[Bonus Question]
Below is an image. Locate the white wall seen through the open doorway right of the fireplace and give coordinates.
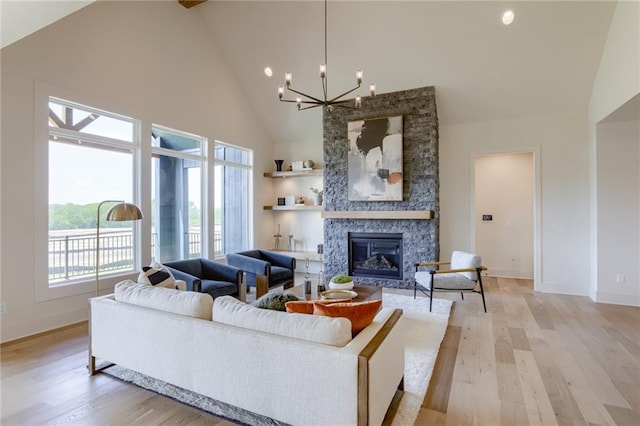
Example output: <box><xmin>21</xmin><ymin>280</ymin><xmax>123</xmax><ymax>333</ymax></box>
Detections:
<box><xmin>474</xmin><ymin>153</ymin><xmax>534</xmax><ymax>279</ymax></box>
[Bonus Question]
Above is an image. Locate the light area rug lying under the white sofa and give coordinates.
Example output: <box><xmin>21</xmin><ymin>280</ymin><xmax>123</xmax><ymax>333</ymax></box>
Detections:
<box><xmin>103</xmin><ymin>292</ymin><xmax>451</xmax><ymax>426</ymax></box>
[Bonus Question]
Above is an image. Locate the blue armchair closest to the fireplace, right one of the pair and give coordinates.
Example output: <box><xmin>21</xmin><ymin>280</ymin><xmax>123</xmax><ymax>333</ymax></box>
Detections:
<box><xmin>227</xmin><ymin>250</ymin><xmax>296</xmax><ymax>298</ymax></box>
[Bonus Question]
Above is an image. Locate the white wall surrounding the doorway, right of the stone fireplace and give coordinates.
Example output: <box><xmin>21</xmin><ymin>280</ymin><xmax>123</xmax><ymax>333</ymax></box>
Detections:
<box><xmin>440</xmin><ymin>113</ymin><xmax>590</xmax><ymax>295</ymax></box>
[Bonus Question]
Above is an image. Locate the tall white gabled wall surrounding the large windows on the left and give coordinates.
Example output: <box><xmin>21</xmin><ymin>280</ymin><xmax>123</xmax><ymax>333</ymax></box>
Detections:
<box><xmin>0</xmin><ymin>2</ymin><xmax>272</xmax><ymax>341</ymax></box>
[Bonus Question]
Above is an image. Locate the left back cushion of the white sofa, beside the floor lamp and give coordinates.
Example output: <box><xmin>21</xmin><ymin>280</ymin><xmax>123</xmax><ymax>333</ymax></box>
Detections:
<box><xmin>115</xmin><ymin>280</ymin><xmax>213</xmax><ymax>321</ymax></box>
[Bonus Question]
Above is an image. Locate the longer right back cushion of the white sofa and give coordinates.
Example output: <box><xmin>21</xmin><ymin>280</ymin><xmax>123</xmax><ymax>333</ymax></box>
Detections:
<box><xmin>213</xmin><ymin>296</ymin><xmax>351</xmax><ymax>346</ymax></box>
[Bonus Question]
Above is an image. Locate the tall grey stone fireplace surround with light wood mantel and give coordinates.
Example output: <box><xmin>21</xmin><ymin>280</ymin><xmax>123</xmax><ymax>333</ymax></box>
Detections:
<box><xmin>323</xmin><ymin>87</ymin><xmax>440</xmax><ymax>288</ymax></box>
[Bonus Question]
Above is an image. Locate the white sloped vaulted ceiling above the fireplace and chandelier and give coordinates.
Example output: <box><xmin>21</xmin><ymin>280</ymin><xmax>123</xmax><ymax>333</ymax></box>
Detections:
<box><xmin>1</xmin><ymin>0</ymin><xmax>615</xmax><ymax>142</ymax></box>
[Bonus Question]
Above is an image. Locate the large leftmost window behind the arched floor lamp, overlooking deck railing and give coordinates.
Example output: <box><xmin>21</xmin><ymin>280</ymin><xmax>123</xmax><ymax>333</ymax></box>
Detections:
<box><xmin>48</xmin><ymin>97</ymin><xmax>139</xmax><ymax>287</ymax></box>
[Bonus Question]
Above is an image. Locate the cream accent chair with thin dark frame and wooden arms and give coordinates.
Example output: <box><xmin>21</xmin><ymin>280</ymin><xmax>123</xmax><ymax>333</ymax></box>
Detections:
<box><xmin>413</xmin><ymin>251</ymin><xmax>487</xmax><ymax>312</ymax></box>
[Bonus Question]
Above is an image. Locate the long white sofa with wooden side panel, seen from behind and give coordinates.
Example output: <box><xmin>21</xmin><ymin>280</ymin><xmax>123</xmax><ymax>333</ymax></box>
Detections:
<box><xmin>89</xmin><ymin>282</ymin><xmax>404</xmax><ymax>425</ymax></box>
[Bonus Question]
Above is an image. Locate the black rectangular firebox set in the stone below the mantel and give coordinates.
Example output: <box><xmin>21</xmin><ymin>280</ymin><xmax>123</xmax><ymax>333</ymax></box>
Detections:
<box><xmin>349</xmin><ymin>232</ymin><xmax>402</xmax><ymax>280</ymax></box>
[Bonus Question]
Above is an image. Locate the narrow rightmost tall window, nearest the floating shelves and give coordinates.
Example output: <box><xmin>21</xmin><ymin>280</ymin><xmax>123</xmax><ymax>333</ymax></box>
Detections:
<box><xmin>214</xmin><ymin>141</ymin><xmax>253</xmax><ymax>257</ymax></box>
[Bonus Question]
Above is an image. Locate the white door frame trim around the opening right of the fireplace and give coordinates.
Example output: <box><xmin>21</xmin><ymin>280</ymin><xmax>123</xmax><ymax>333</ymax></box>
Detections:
<box><xmin>469</xmin><ymin>146</ymin><xmax>542</xmax><ymax>291</ymax></box>
